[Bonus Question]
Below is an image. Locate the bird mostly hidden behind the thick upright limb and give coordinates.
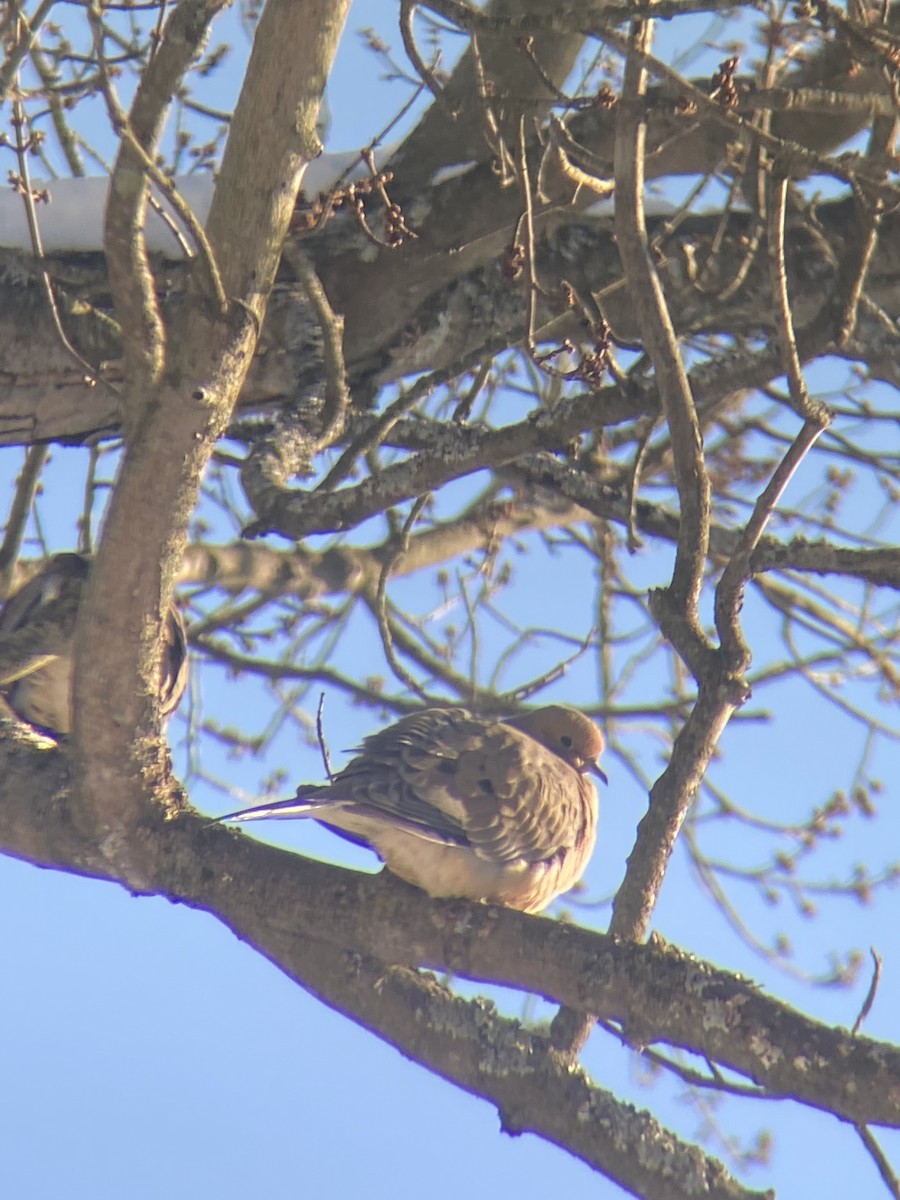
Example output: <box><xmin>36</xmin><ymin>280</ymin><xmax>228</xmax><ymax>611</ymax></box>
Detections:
<box><xmin>0</xmin><ymin>553</ymin><xmax>188</xmax><ymax>733</ymax></box>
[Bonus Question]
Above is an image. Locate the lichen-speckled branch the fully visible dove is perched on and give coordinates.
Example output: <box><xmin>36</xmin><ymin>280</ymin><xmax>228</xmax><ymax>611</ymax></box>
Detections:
<box><xmin>0</xmin><ymin>744</ymin><xmax>900</xmax><ymax>1127</ymax></box>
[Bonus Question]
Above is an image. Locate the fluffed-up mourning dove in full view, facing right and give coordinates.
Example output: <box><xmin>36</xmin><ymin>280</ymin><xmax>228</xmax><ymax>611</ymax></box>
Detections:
<box><xmin>220</xmin><ymin>704</ymin><xmax>606</xmax><ymax>912</ymax></box>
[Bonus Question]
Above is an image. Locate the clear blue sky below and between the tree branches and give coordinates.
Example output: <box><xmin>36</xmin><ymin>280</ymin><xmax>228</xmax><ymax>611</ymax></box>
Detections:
<box><xmin>0</xmin><ymin>0</ymin><xmax>900</xmax><ymax>1200</ymax></box>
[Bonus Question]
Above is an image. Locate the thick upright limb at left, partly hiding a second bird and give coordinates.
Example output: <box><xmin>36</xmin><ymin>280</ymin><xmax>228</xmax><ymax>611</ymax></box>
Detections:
<box><xmin>73</xmin><ymin>0</ymin><xmax>349</xmax><ymax>887</ymax></box>
